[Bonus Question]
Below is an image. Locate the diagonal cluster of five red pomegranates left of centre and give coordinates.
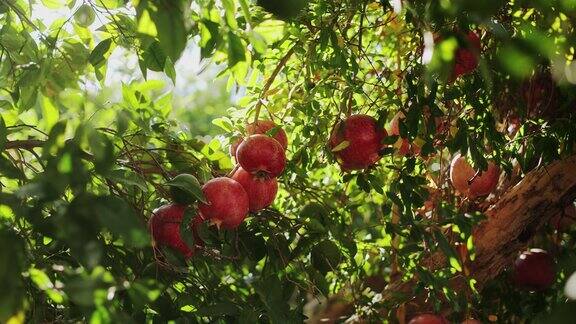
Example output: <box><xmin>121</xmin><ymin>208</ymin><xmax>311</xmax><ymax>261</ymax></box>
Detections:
<box><xmin>150</xmin><ymin>121</ymin><xmax>288</xmax><ymax>258</ymax></box>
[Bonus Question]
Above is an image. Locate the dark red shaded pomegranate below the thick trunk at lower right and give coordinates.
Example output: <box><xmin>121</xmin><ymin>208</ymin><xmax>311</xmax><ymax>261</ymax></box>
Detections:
<box><xmin>512</xmin><ymin>249</ymin><xmax>556</xmax><ymax>291</ymax></box>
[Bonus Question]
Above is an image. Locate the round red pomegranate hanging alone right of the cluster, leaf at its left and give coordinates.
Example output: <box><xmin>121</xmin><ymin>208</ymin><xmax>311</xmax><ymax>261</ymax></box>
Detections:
<box><xmin>329</xmin><ymin>115</ymin><xmax>388</xmax><ymax>171</ymax></box>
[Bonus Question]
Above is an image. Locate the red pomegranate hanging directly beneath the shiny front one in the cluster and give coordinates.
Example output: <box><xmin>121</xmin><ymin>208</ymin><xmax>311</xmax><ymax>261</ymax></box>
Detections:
<box><xmin>232</xmin><ymin>168</ymin><xmax>278</xmax><ymax>212</ymax></box>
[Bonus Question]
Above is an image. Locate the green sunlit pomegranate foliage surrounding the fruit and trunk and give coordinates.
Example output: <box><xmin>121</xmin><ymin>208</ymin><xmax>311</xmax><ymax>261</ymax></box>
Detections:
<box><xmin>0</xmin><ymin>0</ymin><xmax>576</xmax><ymax>323</ymax></box>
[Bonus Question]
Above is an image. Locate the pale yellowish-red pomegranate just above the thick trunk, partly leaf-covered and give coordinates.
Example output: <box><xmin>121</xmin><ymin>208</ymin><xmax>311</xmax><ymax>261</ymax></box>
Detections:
<box><xmin>450</xmin><ymin>154</ymin><xmax>500</xmax><ymax>198</ymax></box>
